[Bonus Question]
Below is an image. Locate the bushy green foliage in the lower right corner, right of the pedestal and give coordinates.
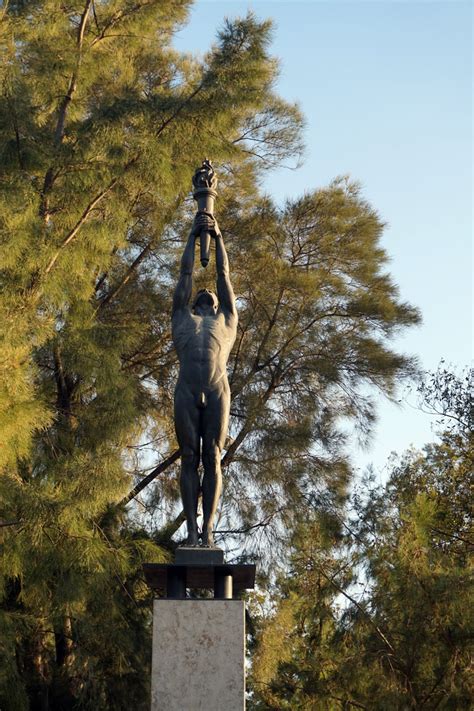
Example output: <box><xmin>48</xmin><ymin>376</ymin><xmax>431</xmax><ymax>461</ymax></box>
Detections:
<box><xmin>253</xmin><ymin>371</ymin><xmax>473</xmax><ymax>711</ymax></box>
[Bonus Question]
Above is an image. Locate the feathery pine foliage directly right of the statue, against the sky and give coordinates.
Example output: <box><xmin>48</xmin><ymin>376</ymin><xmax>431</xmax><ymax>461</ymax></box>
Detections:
<box><xmin>207</xmin><ymin>179</ymin><xmax>418</xmax><ymax>551</ymax></box>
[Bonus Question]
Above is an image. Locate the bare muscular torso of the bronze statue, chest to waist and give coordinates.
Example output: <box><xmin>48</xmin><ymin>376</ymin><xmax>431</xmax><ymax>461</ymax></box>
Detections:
<box><xmin>173</xmin><ymin>308</ymin><xmax>236</xmax><ymax>391</ymax></box>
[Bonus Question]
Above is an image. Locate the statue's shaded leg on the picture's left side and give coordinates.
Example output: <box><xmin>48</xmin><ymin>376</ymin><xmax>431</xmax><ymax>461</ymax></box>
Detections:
<box><xmin>174</xmin><ymin>385</ymin><xmax>199</xmax><ymax>546</ymax></box>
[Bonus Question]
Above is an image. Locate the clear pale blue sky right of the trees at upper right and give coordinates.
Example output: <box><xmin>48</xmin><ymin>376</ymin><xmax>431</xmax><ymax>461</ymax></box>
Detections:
<box><xmin>175</xmin><ymin>0</ymin><xmax>472</xmax><ymax>478</ymax></box>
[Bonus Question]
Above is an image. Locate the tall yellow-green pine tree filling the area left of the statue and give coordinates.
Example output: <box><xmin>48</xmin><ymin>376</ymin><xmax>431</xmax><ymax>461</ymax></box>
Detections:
<box><xmin>0</xmin><ymin>0</ymin><xmax>301</xmax><ymax>711</ymax></box>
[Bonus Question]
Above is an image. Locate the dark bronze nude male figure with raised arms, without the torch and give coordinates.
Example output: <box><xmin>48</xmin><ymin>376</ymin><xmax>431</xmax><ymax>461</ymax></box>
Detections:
<box><xmin>172</xmin><ymin>213</ymin><xmax>237</xmax><ymax>546</ymax></box>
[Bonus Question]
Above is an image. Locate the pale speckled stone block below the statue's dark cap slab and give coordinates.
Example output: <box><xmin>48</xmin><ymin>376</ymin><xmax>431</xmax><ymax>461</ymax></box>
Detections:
<box><xmin>151</xmin><ymin>599</ymin><xmax>245</xmax><ymax>711</ymax></box>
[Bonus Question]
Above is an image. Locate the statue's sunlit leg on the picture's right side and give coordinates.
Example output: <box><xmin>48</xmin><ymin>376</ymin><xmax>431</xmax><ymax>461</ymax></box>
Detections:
<box><xmin>201</xmin><ymin>388</ymin><xmax>230</xmax><ymax>546</ymax></box>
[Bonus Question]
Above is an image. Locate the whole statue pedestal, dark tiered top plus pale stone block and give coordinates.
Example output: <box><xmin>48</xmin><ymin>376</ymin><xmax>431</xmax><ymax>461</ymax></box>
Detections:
<box><xmin>143</xmin><ymin>546</ymin><xmax>255</xmax><ymax>711</ymax></box>
